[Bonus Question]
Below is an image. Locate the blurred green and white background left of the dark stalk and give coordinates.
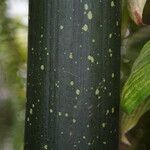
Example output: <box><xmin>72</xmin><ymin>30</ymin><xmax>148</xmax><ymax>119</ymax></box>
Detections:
<box><xmin>0</xmin><ymin>0</ymin><xmax>27</xmax><ymax>150</ymax></box>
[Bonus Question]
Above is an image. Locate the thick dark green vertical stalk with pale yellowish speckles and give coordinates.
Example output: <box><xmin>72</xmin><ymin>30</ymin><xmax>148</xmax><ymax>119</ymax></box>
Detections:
<box><xmin>25</xmin><ymin>0</ymin><xmax>120</xmax><ymax>150</ymax></box>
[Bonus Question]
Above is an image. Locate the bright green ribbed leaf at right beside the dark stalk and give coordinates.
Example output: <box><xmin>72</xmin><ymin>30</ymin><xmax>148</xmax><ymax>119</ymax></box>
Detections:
<box><xmin>121</xmin><ymin>41</ymin><xmax>150</xmax><ymax>113</ymax></box>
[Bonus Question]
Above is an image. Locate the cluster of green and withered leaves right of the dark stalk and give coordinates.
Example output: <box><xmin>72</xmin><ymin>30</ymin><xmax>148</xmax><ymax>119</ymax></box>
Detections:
<box><xmin>120</xmin><ymin>0</ymin><xmax>150</xmax><ymax>150</ymax></box>
